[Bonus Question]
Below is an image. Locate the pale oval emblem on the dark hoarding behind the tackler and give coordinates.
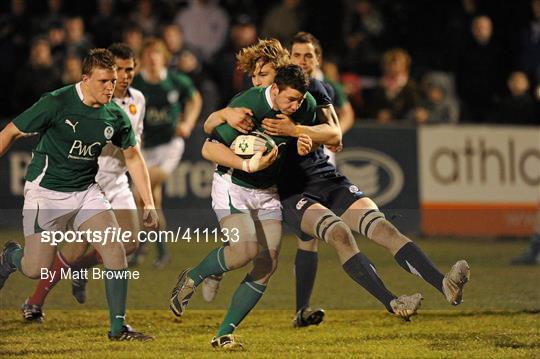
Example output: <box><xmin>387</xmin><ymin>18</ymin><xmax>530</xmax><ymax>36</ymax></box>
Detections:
<box><xmin>337</xmin><ymin>147</ymin><xmax>404</xmax><ymax>206</ymax></box>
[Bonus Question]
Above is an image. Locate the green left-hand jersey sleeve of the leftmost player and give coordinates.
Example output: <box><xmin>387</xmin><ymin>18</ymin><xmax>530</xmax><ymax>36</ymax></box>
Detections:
<box><xmin>13</xmin><ymin>94</ymin><xmax>59</xmax><ymax>133</ymax></box>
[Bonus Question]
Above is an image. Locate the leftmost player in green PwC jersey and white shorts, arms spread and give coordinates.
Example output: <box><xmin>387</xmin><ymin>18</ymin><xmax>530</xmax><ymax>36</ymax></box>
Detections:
<box><xmin>0</xmin><ymin>49</ymin><xmax>158</xmax><ymax>341</ymax></box>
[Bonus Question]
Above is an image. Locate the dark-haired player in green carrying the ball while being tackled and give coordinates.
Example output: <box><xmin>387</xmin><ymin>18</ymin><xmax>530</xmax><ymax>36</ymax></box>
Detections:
<box><xmin>170</xmin><ymin>65</ymin><xmax>316</xmax><ymax>349</ymax></box>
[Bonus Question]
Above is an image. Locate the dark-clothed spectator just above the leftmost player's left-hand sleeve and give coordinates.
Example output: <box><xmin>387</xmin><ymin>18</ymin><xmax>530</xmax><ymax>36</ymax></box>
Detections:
<box><xmin>13</xmin><ymin>37</ymin><xmax>62</xmax><ymax>113</ymax></box>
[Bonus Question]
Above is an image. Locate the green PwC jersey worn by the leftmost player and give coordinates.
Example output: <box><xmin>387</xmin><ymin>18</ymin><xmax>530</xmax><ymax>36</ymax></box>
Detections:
<box><xmin>13</xmin><ymin>85</ymin><xmax>137</xmax><ymax>192</ymax></box>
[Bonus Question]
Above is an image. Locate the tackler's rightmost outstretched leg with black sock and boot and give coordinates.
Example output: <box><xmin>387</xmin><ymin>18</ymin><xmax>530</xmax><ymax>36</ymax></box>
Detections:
<box><xmin>341</xmin><ymin>197</ymin><xmax>469</xmax><ymax>305</ymax></box>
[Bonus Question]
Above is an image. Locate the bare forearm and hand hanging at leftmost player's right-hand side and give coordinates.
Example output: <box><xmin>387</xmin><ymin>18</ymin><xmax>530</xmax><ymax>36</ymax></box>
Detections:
<box><xmin>122</xmin><ymin>146</ymin><xmax>159</xmax><ymax>228</ymax></box>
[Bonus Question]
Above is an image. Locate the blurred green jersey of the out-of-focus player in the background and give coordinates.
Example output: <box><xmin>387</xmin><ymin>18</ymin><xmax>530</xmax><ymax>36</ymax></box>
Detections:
<box><xmin>133</xmin><ymin>70</ymin><xmax>195</xmax><ymax>148</ymax></box>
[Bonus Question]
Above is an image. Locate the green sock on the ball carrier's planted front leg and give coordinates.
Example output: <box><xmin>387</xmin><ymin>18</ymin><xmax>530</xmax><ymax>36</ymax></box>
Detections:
<box><xmin>216</xmin><ymin>274</ymin><xmax>266</xmax><ymax>337</ymax></box>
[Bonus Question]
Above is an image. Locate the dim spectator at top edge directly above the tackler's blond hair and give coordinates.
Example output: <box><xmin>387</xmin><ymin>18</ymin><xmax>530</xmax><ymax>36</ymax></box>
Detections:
<box><xmin>261</xmin><ymin>0</ymin><xmax>303</xmax><ymax>46</ymax></box>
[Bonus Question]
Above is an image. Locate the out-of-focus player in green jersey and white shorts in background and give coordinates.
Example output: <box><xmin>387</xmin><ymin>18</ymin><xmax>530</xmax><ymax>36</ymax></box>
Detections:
<box><xmin>133</xmin><ymin>38</ymin><xmax>202</xmax><ymax>268</ymax></box>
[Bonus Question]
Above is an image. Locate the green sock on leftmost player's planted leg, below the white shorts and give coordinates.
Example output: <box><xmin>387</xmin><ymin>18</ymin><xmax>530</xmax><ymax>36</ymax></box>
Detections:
<box><xmin>104</xmin><ymin>269</ymin><xmax>128</xmax><ymax>335</ymax></box>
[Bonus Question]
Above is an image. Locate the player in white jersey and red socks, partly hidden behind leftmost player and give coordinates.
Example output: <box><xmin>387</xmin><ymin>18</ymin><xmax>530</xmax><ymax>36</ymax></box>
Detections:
<box><xmin>21</xmin><ymin>43</ymin><xmax>145</xmax><ymax>321</ymax></box>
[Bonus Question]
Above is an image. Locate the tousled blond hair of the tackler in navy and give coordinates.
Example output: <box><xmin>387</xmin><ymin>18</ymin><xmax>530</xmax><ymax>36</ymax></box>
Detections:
<box><xmin>236</xmin><ymin>39</ymin><xmax>290</xmax><ymax>74</ymax></box>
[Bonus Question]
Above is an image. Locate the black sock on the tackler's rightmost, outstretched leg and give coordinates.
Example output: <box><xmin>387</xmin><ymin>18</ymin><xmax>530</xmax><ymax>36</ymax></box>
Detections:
<box><xmin>394</xmin><ymin>242</ymin><xmax>444</xmax><ymax>293</ymax></box>
